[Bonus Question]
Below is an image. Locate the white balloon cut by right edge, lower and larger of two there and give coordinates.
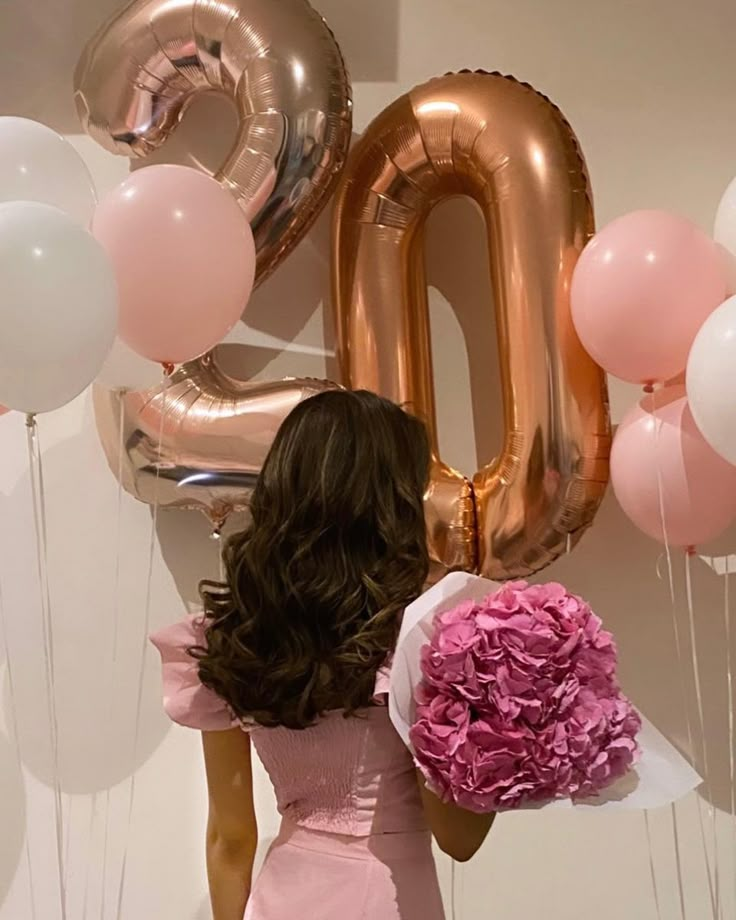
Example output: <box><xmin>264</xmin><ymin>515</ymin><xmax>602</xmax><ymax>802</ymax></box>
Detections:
<box><xmin>687</xmin><ymin>297</ymin><xmax>736</xmax><ymax>464</ymax></box>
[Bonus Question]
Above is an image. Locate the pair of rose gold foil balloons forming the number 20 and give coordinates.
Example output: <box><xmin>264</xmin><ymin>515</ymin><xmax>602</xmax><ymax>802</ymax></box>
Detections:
<box><xmin>77</xmin><ymin>18</ymin><xmax>610</xmax><ymax>578</ymax></box>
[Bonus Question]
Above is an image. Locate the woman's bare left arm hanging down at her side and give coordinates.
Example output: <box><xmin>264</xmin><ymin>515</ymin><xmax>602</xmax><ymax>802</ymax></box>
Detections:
<box><xmin>202</xmin><ymin>728</ymin><xmax>258</xmax><ymax>920</ymax></box>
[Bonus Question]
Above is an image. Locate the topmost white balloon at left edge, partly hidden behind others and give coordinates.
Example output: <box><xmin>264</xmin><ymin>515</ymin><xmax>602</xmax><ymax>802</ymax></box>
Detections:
<box><xmin>0</xmin><ymin>115</ymin><xmax>97</xmax><ymax>227</ymax></box>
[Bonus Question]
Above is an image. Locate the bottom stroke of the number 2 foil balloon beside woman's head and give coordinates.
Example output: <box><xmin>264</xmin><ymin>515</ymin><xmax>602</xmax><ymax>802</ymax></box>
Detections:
<box><xmin>94</xmin><ymin>355</ymin><xmax>335</xmax><ymax>530</ymax></box>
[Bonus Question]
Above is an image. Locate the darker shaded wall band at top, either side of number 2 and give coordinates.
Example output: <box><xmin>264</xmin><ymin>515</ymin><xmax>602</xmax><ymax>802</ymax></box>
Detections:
<box><xmin>0</xmin><ymin>0</ymin><xmax>399</xmax><ymax>134</ymax></box>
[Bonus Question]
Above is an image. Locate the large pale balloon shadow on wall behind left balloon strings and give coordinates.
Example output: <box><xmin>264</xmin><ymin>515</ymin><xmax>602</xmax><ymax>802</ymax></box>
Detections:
<box><xmin>2</xmin><ymin>422</ymin><xmax>173</xmax><ymax>796</ymax></box>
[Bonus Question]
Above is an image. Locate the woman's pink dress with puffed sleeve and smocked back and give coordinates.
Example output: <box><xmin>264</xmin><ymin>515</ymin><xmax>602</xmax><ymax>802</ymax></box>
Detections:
<box><xmin>152</xmin><ymin>618</ymin><xmax>445</xmax><ymax>920</ymax></box>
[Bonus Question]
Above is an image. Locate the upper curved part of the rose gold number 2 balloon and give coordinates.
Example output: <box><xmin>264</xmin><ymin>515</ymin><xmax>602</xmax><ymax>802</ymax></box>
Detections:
<box><xmin>74</xmin><ymin>0</ymin><xmax>352</xmax><ymax>281</ymax></box>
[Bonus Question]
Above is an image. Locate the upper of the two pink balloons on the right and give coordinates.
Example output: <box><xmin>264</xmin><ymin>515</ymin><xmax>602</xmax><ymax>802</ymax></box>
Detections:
<box><xmin>571</xmin><ymin>211</ymin><xmax>726</xmax><ymax>384</ymax></box>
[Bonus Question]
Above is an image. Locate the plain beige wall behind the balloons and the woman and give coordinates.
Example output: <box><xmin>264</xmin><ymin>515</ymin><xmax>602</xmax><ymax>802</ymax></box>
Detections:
<box><xmin>0</xmin><ymin>0</ymin><xmax>736</xmax><ymax>920</ymax></box>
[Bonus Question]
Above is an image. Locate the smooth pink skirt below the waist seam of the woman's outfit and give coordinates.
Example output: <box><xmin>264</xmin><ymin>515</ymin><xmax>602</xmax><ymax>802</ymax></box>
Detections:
<box><xmin>244</xmin><ymin>822</ymin><xmax>445</xmax><ymax>920</ymax></box>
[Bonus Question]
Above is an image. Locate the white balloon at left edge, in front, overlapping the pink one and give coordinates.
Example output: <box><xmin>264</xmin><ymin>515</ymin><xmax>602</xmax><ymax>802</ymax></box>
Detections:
<box><xmin>0</xmin><ymin>201</ymin><xmax>117</xmax><ymax>413</ymax></box>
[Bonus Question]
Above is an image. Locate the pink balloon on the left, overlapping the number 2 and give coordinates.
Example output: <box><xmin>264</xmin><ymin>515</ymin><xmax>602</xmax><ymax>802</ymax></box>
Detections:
<box><xmin>92</xmin><ymin>165</ymin><xmax>256</xmax><ymax>364</ymax></box>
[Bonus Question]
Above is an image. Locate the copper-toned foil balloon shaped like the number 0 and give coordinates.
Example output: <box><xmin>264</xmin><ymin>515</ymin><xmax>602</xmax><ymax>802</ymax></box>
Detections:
<box><xmin>334</xmin><ymin>72</ymin><xmax>610</xmax><ymax>579</ymax></box>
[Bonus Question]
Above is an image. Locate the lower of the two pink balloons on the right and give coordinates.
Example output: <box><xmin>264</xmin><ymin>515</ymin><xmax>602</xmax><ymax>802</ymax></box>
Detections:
<box><xmin>611</xmin><ymin>386</ymin><xmax>736</xmax><ymax>547</ymax></box>
